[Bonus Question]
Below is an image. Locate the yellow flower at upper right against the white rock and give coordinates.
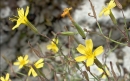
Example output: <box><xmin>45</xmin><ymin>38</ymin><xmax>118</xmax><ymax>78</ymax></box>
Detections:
<box><xmin>99</xmin><ymin>0</ymin><xmax>116</xmax><ymax>17</ymax></box>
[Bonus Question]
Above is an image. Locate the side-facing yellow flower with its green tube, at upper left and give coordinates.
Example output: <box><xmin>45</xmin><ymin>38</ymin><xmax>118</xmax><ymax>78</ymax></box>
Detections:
<box><xmin>9</xmin><ymin>6</ymin><xmax>38</xmax><ymax>32</ymax></box>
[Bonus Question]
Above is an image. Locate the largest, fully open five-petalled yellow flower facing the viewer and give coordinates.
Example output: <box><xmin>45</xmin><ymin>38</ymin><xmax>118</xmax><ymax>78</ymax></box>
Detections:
<box><xmin>75</xmin><ymin>39</ymin><xmax>103</xmax><ymax>66</ymax></box>
